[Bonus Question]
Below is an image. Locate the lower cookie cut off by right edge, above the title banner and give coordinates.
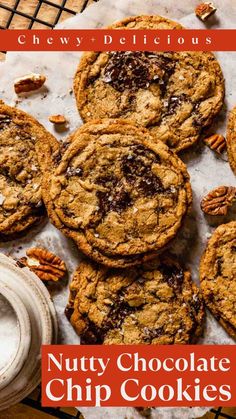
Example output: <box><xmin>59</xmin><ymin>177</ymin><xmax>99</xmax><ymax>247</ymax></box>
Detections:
<box><xmin>200</xmin><ymin>221</ymin><xmax>236</xmax><ymax>339</ymax></box>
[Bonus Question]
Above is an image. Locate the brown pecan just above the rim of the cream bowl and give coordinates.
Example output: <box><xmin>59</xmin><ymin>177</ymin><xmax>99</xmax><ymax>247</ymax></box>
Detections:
<box><xmin>18</xmin><ymin>247</ymin><xmax>67</xmax><ymax>281</ymax></box>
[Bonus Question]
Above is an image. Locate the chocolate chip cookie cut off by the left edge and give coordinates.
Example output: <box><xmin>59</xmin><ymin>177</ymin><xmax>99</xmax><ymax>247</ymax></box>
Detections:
<box><xmin>0</xmin><ymin>101</ymin><xmax>57</xmax><ymax>241</ymax></box>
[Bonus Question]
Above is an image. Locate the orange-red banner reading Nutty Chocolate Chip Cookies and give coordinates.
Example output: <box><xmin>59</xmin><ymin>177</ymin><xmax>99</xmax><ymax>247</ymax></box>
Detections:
<box><xmin>42</xmin><ymin>345</ymin><xmax>236</xmax><ymax>406</ymax></box>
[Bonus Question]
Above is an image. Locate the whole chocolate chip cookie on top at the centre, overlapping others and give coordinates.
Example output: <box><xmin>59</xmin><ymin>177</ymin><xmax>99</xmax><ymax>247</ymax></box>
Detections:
<box><xmin>40</xmin><ymin>119</ymin><xmax>191</xmax><ymax>267</ymax></box>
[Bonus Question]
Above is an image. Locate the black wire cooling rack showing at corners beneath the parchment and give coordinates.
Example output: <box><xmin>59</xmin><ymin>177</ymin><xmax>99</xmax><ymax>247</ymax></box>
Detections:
<box><xmin>0</xmin><ymin>0</ymin><xmax>236</xmax><ymax>419</ymax></box>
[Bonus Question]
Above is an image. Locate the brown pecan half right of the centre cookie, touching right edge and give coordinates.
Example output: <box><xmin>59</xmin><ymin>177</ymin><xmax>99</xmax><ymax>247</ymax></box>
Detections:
<box><xmin>201</xmin><ymin>186</ymin><xmax>236</xmax><ymax>215</ymax></box>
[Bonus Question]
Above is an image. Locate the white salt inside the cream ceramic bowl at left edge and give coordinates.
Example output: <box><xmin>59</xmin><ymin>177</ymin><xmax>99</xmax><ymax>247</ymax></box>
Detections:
<box><xmin>0</xmin><ymin>295</ymin><xmax>20</xmax><ymax>372</ymax></box>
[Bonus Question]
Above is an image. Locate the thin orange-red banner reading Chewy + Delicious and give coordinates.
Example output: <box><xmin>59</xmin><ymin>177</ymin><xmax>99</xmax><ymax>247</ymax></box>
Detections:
<box><xmin>0</xmin><ymin>29</ymin><xmax>236</xmax><ymax>51</ymax></box>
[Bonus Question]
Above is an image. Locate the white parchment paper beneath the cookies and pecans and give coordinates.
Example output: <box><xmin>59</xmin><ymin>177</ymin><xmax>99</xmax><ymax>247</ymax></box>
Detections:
<box><xmin>0</xmin><ymin>0</ymin><xmax>236</xmax><ymax>419</ymax></box>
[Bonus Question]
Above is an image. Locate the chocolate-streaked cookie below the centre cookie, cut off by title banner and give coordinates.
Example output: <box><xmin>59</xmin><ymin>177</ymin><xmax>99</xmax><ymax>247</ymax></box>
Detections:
<box><xmin>66</xmin><ymin>256</ymin><xmax>204</xmax><ymax>344</ymax></box>
